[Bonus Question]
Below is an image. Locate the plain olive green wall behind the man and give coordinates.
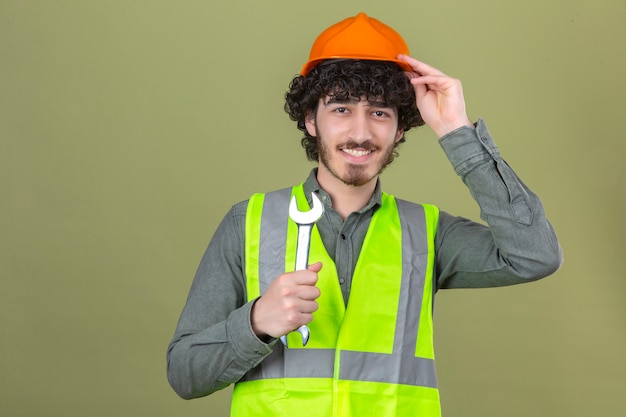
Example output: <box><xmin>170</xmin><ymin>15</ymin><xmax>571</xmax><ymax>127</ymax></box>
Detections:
<box><xmin>0</xmin><ymin>0</ymin><xmax>626</xmax><ymax>417</ymax></box>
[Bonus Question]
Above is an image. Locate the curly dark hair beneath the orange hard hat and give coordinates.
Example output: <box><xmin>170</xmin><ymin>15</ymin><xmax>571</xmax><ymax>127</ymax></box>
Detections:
<box><xmin>285</xmin><ymin>59</ymin><xmax>424</xmax><ymax>161</ymax></box>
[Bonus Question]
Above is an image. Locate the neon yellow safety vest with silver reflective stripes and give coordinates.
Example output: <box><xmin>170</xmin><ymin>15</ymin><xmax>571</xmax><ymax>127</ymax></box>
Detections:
<box><xmin>231</xmin><ymin>184</ymin><xmax>441</xmax><ymax>417</ymax></box>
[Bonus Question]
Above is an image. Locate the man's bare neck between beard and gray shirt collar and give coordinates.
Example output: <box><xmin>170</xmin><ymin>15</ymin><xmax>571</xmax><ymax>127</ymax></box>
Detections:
<box><xmin>317</xmin><ymin>169</ymin><xmax>378</xmax><ymax>220</ymax></box>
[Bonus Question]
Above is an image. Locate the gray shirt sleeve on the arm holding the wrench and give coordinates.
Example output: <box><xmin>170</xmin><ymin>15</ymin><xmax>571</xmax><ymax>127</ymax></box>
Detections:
<box><xmin>167</xmin><ymin>203</ymin><xmax>275</xmax><ymax>399</ymax></box>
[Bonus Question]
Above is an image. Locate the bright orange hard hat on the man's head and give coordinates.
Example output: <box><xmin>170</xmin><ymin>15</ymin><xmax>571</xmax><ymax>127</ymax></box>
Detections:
<box><xmin>300</xmin><ymin>13</ymin><xmax>413</xmax><ymax>75</ymax></box>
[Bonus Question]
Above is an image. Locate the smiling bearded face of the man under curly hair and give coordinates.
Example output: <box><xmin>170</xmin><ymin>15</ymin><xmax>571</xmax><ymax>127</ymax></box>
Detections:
<box><xmin>305</xmin><ymin>96</ymin><xmax>404</xmax><ymax>187</ymax></box>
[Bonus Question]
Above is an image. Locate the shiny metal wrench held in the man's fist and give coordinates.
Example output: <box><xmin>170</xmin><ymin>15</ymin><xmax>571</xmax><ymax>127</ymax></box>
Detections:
<box><xmin>280</xmin><ymin>193</ymin><xmax>324</xmax><ymax>347</ymax></box>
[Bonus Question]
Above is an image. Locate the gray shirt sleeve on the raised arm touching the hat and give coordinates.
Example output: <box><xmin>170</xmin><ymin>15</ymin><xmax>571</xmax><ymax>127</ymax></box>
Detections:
<box><xmin>435</xmin><ymin>119</ymin><xmax>563</xmax><ymax>288</ymax></box>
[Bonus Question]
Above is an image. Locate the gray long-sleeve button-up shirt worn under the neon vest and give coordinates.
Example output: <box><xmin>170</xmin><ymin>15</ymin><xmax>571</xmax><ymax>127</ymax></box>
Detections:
<box><xmin>167</xmin><ymin>120</ymin><xmax>562</xmax><ymax>398</ymax></box>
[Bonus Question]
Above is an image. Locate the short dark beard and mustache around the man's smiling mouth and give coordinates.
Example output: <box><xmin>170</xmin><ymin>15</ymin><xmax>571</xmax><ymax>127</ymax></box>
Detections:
<box><xmin>317</xmin><ymin>136</ymin><xmax>395</xmax><ymax>187</ymax></box>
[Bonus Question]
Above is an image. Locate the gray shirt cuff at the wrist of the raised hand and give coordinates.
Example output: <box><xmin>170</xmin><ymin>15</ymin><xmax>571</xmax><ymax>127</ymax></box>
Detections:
<box><xmin>439</xmin><ymin>119</ymin><xmax>500</xmax><ymax>176</ymax></box>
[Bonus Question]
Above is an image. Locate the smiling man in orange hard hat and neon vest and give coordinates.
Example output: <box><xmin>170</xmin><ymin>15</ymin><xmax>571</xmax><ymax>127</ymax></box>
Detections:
<box><xmin>168</xmin><ymin>13</ymin><xmax>562</xmax><ymax>416</ymax></box>
